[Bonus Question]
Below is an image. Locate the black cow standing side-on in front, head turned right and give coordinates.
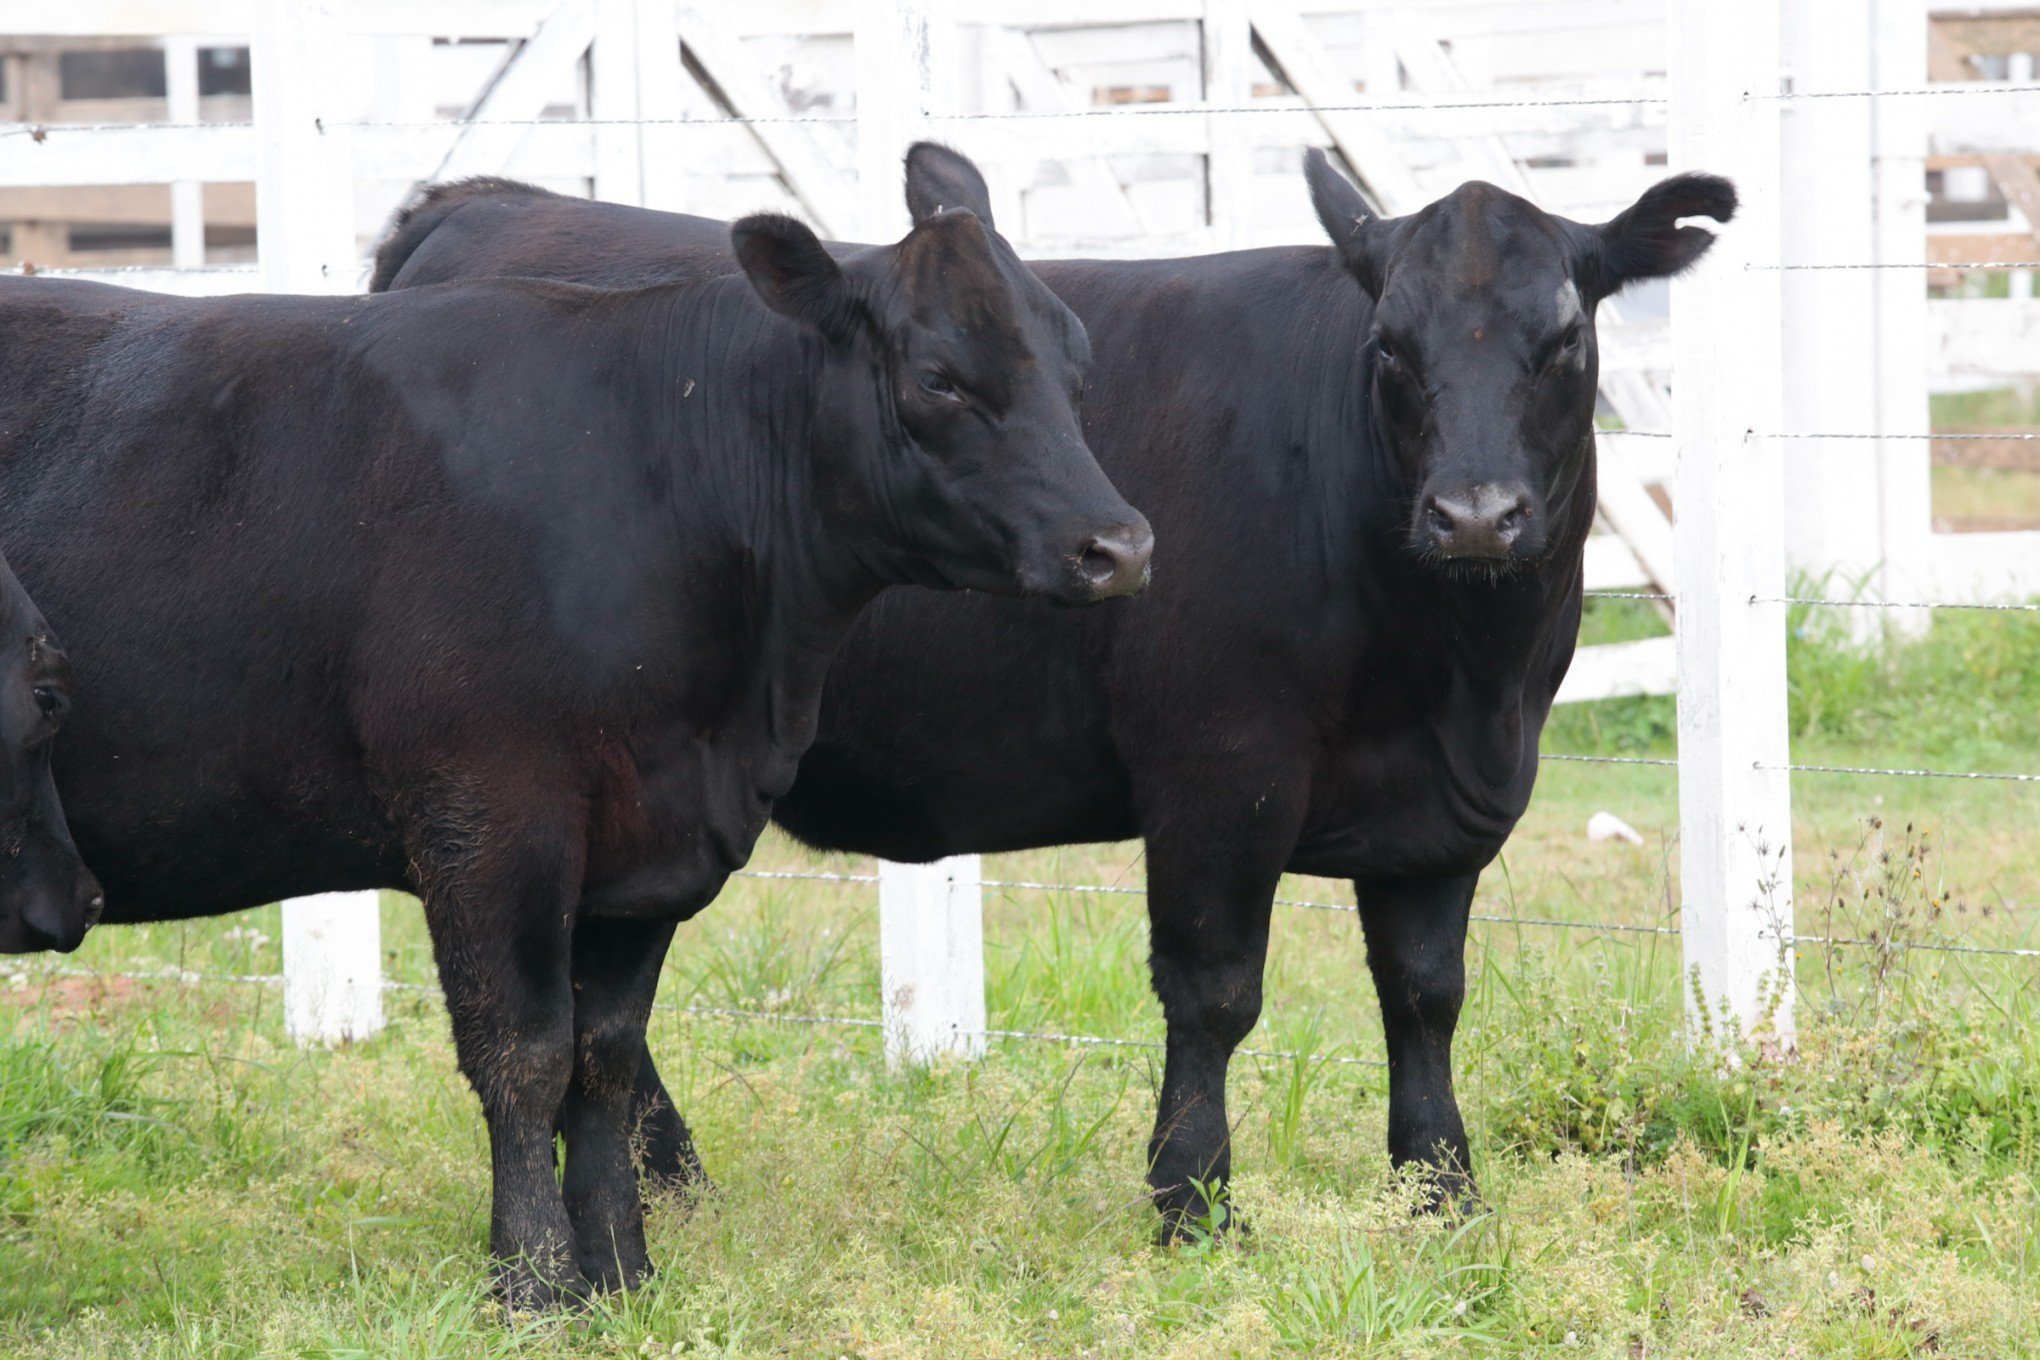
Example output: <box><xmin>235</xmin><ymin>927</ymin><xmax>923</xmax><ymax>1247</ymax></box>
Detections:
<box><xmin>0</xmin><ymin>151</ymin><xmax>1151</xmax><ymax>1305</ymax></box>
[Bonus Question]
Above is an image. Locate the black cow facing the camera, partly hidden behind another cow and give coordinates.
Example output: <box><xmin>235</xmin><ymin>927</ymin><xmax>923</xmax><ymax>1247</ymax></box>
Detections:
<box><xmin>373</xmin><ymin>153</ymin><xmax>1736</xmax><ymax>1234</ymax></box>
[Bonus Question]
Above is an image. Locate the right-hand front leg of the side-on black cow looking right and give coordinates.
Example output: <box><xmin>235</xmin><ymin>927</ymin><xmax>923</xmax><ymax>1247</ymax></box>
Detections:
<box><xmin>561</xmin><ymin>920</ymin><xmax>673</xmax><ymax>1289</ymax></box>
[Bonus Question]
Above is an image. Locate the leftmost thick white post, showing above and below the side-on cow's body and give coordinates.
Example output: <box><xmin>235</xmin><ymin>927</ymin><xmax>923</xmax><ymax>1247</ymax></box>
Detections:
<box><xmin>251</xmin><ymin>0</ymin><xmax>384</xmax><ymax>1044</ymax></box>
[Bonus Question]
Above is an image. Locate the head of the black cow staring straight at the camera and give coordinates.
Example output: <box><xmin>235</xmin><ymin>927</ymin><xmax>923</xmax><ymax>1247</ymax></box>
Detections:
<box><xmin>1304</xmin><ymin>149</ymin><xmax>1736</xmax><ymax>571</ymax></box>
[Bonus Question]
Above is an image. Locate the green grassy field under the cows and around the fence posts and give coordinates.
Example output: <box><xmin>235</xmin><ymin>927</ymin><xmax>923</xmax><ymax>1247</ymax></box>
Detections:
<box><xmin>0</xmin><ymin>610</ymin><xmax>2040</xmax><ymax>1360</ymax></box>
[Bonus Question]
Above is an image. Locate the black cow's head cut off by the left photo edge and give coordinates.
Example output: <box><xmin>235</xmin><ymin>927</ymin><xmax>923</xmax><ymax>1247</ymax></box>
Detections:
<box><xmin>0</xmin><ymin>561</ymin><xmax>106</xmax><ymax>954</ymax></box>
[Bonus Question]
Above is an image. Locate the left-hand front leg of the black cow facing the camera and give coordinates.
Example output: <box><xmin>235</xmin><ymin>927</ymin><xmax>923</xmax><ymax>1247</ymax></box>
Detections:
<box><xmin>1146</xmin><ymin>782</ymin><xmax>1295</xmax><ymax>1242</ymax></box>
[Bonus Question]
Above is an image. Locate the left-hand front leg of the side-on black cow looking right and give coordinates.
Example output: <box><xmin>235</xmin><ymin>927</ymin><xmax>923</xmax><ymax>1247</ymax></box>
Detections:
<box><xmin>416</xmin><ymin>812</ymin><xmax>588</xmax><ymax>1309</ymax></box>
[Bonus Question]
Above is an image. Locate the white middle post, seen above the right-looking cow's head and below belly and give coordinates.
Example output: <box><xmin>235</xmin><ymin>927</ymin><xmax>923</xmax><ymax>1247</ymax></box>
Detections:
<box><xmin>857</xmin><ymin>0</ymin><xmax>985</xmax><ymax>1064</ymax></box>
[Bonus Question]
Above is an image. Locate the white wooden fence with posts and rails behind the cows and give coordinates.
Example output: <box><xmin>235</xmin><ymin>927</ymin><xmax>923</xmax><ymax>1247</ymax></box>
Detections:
<box><xmin>0</xmin><ymin>0</ymin><xmax>2040</xmax><ymax>1058</ymax></box>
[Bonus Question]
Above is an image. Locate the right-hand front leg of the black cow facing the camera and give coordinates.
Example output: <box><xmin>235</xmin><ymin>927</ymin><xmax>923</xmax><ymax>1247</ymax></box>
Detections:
<box><xmin>1353</xmin><ymin>875</ymin><xmax>1479</xmax><ymax>1203</ymax></box>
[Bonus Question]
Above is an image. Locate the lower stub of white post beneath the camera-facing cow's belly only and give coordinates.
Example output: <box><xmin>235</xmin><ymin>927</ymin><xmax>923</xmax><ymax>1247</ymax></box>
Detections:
<box><xmin>879</xmin><ymin>854</ymin><xmax>985</xmax><ymax>1064</ymax></box>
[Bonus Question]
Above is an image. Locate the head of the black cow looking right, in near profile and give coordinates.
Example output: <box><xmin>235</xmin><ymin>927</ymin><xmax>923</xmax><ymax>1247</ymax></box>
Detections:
<box><xmin>730</xmin><ymin>143</ymin><xmax>1155</xmax><ymax>604</ymax></box>
